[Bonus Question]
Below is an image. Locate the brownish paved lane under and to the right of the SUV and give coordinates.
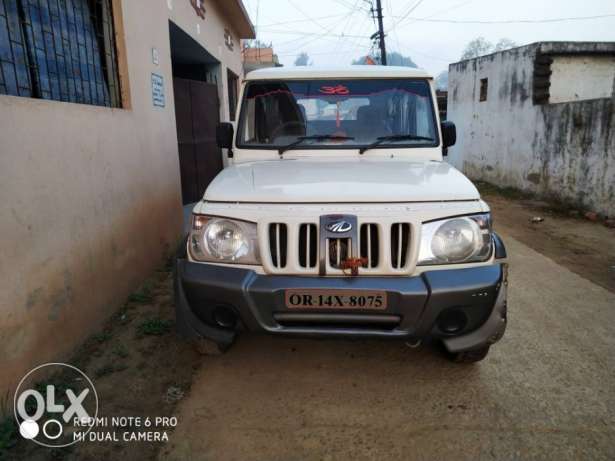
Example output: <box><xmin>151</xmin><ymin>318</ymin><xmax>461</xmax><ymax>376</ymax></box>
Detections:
<box><xmin>159</xmin><ymin>234</ymin><xmax>615</xmax><ymax>460</ymax></box>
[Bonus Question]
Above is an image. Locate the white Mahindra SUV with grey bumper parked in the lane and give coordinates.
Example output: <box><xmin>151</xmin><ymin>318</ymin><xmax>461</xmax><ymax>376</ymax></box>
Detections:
<box><xmin>175</xmin><ymin>66</ymin><xmax>507</xmax><ymax>362</ymax></box>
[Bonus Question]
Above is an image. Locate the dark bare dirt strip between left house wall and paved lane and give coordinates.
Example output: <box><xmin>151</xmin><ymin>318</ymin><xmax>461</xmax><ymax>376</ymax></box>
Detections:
<box><xmin>6</xmin><ymin>265</ymin><xmax>203</xmax><ymax>461</ymax></box>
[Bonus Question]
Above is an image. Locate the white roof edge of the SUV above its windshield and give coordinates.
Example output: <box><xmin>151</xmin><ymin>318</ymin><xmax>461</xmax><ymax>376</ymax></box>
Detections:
<box><xmin>246</xmin><ymin>65</ymin><xmax>432</xmax><ymax>80</ymax></box>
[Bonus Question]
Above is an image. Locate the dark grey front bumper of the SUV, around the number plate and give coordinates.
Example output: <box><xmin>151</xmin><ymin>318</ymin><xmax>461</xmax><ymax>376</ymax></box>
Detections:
<box><xmin>175</xmin><ymin>239</ymin><xmax>506</xmax><ymax>352</ymax></box>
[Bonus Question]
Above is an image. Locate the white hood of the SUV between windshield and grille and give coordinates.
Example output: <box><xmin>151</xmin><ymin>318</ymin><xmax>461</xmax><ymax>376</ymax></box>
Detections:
<box><xmin>205</xmin><ymin>159</ymin><xmax>479</xmax><ymax>203</ymax></box>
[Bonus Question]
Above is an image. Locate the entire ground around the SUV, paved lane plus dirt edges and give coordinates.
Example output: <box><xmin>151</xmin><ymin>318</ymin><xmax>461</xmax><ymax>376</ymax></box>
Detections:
<box><xmin>7</xmin><ymin>185</ymin><xmax>615</xmax><ymax>460</ymax></box>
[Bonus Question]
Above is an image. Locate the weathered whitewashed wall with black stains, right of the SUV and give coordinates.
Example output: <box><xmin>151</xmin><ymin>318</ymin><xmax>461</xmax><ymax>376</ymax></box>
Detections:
<box><xmin>448</xmin><ymin>44</ymin><xmax>615</xmax><ymax>216</ymax></box>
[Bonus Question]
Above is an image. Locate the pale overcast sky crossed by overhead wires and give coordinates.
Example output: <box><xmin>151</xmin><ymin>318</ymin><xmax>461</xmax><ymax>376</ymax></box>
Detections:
<box><xmin>243</xmin><ymin>0</ymin><xmax>615</xmax><ymax>75</ymax></box>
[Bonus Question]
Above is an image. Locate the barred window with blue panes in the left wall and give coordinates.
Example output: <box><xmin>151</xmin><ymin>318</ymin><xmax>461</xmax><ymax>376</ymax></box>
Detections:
<box><xmin>0</xmin><ymin>0</ymin><xmax>121</xmax><ymax>107</ymax></box>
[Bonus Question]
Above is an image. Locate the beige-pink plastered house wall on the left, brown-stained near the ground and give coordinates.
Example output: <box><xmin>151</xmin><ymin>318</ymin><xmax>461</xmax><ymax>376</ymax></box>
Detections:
<box><xmin>0</xmin><ymin>0</ymin><xmax>250</xmax><ymax>397</ymax></box>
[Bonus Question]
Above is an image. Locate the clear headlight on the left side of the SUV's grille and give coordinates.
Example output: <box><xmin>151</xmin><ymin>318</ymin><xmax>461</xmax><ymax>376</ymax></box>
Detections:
<box><xmin>188</xmin><ymin>215</ymin><xmax>260</xmax><ymax>264</ymax></box>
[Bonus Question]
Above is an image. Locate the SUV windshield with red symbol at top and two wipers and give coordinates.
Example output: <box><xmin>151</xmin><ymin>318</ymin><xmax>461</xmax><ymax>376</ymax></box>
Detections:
<box><xmin>238</xmin><ymin>79</ymin><xmax>438</xmax><ymax>149</ymax></box>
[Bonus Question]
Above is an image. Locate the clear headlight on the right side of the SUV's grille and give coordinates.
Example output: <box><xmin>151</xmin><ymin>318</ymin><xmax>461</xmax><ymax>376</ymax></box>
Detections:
<box><xmin>418</xmin><ymin>213</ymin><xmax>491</xmax><ymax>265</ymax></box>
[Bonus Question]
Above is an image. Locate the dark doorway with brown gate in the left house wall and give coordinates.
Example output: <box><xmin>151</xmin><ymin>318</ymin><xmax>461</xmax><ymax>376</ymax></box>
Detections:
<box><xmin>169</xmin><ymin>22</ymin><xmax>223</xmax><ymax>204</ymax></box>
